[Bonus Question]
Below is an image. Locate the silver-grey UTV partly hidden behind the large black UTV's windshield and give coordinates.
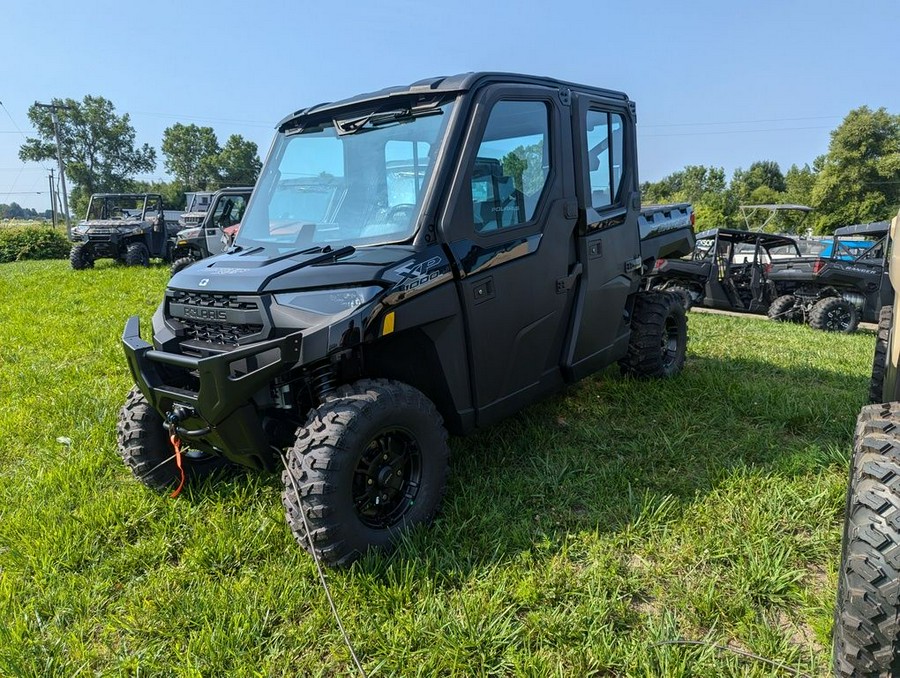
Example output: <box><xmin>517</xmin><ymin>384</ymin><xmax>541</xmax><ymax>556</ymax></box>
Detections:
<box><xmin>172</xmin><ymin>186</ymin><xmax>253</xmax><ymax>275</ymax></box>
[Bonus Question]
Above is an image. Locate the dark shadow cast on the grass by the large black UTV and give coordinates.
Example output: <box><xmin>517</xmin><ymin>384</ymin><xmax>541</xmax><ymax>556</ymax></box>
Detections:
<box><xmin>169</xmin><ymin>357</ymin><xmax>866</xmax><ymax>579</ymax></box>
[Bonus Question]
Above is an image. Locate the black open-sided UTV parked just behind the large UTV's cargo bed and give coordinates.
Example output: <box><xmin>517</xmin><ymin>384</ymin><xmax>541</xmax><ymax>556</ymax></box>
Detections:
<box><xmin>648</xmin><ymin>228</ymin><xmax>800</xmax><ymax>313</ymax></box>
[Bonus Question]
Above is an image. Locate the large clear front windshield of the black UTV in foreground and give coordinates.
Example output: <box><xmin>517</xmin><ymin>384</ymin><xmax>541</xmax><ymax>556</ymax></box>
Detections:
<box><xmin>235</xmin><ymin>97</ymin><xmax>453</xmax><ymax>254</ymax></box>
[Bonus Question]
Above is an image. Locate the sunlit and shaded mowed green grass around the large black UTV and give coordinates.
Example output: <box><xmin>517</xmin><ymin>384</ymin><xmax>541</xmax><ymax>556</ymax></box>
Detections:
<box><xmin>0</xmin><ymin>261</ymin><xmax>874</xmax><ymax>676</ymax></box>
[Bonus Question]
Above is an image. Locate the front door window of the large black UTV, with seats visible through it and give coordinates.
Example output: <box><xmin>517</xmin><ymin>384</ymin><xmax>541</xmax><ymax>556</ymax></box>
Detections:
<box><xmin>472</xmin><ymin>101</ymin><xmax>550</xmax><ymax>235</ymax></box>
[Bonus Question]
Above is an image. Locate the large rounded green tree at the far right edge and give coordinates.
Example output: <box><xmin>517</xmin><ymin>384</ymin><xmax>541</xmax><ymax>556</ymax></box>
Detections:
<box><xmin>812</xmin><ymin>106</ymin><xmax>900</xmax><ymax>233</ymax></box>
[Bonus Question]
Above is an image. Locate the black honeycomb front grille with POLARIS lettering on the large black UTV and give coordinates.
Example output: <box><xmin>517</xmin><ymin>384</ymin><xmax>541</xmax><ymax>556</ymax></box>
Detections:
<box><xmin>169</xmin><ymin>290</ymin><xmax>264</xmax><ymax>345</ymax></box>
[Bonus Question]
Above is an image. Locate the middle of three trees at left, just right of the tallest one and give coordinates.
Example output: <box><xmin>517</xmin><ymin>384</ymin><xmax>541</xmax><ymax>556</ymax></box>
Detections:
<box><xmin>162</xmin><ymin>122</ymin><xmax>221</xmax><ymax>190</ymax></box>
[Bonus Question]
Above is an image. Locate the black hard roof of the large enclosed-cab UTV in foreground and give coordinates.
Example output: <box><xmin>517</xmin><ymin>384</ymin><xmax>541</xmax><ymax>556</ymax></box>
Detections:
<box><xmin>277</xmin><ymin>72</ymin><xmax>628</xmax><ymax>132</ymax></box>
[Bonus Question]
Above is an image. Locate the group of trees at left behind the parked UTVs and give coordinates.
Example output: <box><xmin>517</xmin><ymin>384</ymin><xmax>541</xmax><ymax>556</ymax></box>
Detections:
<box><xmin>19</xmin><ymin>95</ymin><xmax>262</xmax><ymax>216</ymax></box>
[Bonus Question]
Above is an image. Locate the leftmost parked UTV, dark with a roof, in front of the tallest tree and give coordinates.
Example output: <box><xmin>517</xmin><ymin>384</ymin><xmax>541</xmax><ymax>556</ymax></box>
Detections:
<box><xmin>69</xmin><ymin>193</ymin><xmax>177</xmax><ymax>270</ymax></box>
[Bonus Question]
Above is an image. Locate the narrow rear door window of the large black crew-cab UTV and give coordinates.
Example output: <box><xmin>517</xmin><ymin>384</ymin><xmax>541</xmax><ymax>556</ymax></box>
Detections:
<box><xmin>586</xmin><ymin>110</ymin><xmax>625</xmax><ymax>210</ymax></box>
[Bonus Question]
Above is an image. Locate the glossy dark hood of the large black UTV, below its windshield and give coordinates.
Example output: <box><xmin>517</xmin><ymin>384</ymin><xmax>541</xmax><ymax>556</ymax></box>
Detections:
<box><xmin>169</xmin><ymin>246</ymin><xmax>416</xmax><ymax>294</ymax></box>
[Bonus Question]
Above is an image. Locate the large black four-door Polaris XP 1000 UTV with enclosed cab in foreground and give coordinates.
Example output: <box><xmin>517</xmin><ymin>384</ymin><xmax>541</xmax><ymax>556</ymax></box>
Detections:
<box><xmin>118</xmin><ymin>73</ymin><xmax>694</xmax><ymax>566</ymax></box>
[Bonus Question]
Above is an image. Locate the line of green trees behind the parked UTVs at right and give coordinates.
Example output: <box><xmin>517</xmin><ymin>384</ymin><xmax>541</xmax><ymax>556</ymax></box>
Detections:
<box><xmin>641</xmin><ymin>106</ymin><xmax>900</xmax><ymax>234</ymax></box>
